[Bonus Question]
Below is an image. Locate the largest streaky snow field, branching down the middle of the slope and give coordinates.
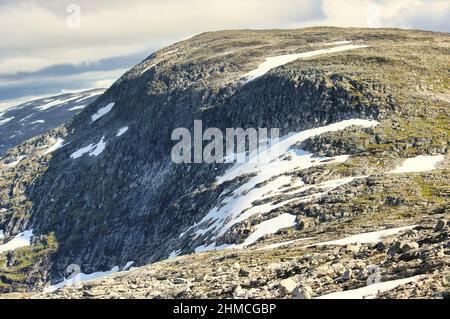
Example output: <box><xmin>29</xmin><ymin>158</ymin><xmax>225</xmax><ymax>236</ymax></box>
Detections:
<box><xmin>180</xmin><ymin>119</ymin><xmax>378</xmax><ymax>252</ymax></box>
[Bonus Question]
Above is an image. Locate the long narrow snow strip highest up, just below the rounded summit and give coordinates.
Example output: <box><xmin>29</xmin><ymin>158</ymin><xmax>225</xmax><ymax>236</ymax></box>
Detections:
<box><xmin>243</xmin><ymin>44</ymin><xmax>368</xmax><ymax>83</ymax></box>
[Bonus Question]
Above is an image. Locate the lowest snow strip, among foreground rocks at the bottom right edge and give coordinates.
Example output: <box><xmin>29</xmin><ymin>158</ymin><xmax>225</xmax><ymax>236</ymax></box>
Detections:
<box><xmin>316</xmin><ymin>275</ymin><xmax>424</xmax><ymax>299</ymax></box>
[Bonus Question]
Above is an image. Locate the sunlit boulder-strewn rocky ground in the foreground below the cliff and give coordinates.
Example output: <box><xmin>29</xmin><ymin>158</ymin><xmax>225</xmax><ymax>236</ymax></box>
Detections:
<box><xmin>31</xmin><ymin>212</ymin><xmax>450</xmax><ymax>299</ymax></box>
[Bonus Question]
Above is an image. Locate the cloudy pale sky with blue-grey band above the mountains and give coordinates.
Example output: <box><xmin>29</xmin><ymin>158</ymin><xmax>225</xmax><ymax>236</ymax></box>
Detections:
<box><xmin>0</xmin><ymin>0</ymin><xmax>450</xmax><ymax>106</ymax></box>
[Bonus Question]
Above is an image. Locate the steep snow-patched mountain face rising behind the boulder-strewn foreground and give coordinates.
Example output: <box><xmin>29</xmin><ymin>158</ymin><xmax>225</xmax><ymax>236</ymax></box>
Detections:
<box><xmin>0</xmin><ymin>28</ymin><xmax>450</xmax><ymax>289</ymax></box>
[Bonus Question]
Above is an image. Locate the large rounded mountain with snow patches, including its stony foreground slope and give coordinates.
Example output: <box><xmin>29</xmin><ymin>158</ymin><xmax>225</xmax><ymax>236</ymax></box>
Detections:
<box><xmin>0</xmin><ymin>28</ymin><xmax>450</xmax><ymax>298</ymax></box>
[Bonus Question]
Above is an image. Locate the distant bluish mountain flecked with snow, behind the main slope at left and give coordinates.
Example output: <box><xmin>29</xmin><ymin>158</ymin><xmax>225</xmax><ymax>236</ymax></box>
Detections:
<box><xmin>0</xmin><ymin>89</ymin><xmax>105</xmax><ymax>157</ymax></box>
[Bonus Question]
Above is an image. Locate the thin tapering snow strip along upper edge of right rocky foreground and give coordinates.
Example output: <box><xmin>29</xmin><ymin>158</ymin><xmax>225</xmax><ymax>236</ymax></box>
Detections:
<box><xmin>307</xmin><ymin>225</ymin><xmax>417</xmax><ymax>247</ymax></box>
